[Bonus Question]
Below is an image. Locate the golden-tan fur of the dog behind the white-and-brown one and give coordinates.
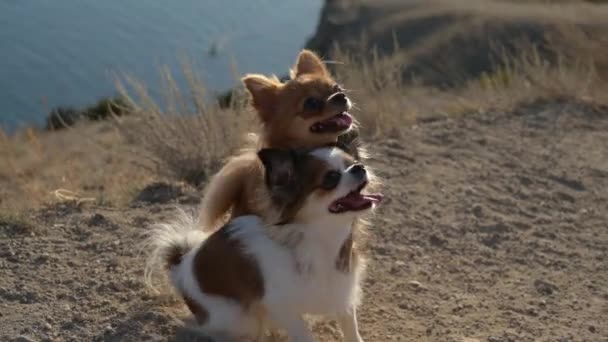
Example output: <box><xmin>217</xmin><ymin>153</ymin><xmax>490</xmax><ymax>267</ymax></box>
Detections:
<box><xmin>199</xmin><ymin>50</ymin><xmax>351</xmax><ymax>231</ymax></box>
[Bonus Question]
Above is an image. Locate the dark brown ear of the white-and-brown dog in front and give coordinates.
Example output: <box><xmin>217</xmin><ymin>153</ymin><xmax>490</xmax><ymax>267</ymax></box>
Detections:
<box><xmin>258</xmin><ymin>148</ymin><xmax>297</xmax><ymax>204</ymax></box>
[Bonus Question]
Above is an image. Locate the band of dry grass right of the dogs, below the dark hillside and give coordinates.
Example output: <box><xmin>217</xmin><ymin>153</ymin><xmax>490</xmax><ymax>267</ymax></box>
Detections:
<box><xmin>334</xmin><ymin>41</ymin><xmax>608</xmax><ymax>138</ymax></box>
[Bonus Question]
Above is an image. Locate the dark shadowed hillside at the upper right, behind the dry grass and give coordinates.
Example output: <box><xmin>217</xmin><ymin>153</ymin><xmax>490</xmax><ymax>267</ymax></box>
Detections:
<box><xmin>306</xmin><ymin>0</ymin><xmax>608</xmax><ymax>86</ymax></box>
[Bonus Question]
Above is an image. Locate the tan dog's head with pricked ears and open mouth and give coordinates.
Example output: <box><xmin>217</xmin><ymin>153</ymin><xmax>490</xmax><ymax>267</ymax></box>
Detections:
<box><xmin>242</xmin><ymin>50</ymin><xmax>353</xmax><ymax>147</ymax></box>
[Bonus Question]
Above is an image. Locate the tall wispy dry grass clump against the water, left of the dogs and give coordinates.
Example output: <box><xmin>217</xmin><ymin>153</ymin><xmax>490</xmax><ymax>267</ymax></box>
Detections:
<box><xmin>118</xmin><ymin>64</ymin><xmax>253</xmax><ymax>186</ymax></box>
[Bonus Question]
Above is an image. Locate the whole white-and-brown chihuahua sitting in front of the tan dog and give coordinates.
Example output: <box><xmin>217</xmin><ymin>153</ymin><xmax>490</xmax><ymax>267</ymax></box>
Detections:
<box><xmin>147</xmin><ymin>147</ymin><xmax>382</xmax><ymax>342</ymax></box>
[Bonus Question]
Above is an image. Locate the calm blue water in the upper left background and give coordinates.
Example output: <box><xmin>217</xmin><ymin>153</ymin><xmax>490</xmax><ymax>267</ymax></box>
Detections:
<box><xmin>0</xmin><ymin>0</ymin><xmax>322</xmax><ymax>130</ymax></box>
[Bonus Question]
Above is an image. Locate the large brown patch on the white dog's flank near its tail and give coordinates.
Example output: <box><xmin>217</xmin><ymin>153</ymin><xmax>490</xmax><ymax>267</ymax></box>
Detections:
<box><xmin>193</xmin><ymin>226</ymin><xmax>264</xmax><ymax>310</ymax></box>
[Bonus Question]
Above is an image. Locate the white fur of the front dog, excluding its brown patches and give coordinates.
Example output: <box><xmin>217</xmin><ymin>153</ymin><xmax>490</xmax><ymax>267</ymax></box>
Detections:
<box><xmin>146</xmin><ymin>148</ymin><xmax>378</xmax><ymax>342</ymax></box>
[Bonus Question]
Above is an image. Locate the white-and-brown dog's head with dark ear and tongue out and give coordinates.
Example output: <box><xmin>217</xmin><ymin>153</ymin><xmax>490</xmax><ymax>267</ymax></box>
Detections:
<box><xmin>258</xmin><ymin>147</ymin><xmax>382</xmax><ymax>223</ymax></box>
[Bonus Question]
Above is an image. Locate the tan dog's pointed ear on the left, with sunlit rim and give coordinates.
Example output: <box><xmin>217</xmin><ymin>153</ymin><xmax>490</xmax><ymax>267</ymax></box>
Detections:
<box><xmin>241</xmin><ymin>74</ymin><xmax>281</xmax><ymax>122</ymax></box>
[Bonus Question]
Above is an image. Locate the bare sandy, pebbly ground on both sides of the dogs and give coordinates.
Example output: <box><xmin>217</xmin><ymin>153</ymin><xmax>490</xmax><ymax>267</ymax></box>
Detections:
<box><xmin>0</xmin><ymin>99</ymin><xmax>608</xmax><ymax>342</ymax></box>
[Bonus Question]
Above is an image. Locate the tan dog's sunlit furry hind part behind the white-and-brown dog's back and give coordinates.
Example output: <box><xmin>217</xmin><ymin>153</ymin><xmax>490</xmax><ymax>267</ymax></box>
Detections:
<box><xmin>198</xmin><ymin>153</ymin><xmax>257</xmax><ymax>232</ymax></box>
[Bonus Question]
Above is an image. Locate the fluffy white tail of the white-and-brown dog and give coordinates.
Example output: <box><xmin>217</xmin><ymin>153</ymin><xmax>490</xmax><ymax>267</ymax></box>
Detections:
<box><xmin>144</xmin><ymin>209</ymin><xmax>207</xmax><ymax>289</ymax></box>
